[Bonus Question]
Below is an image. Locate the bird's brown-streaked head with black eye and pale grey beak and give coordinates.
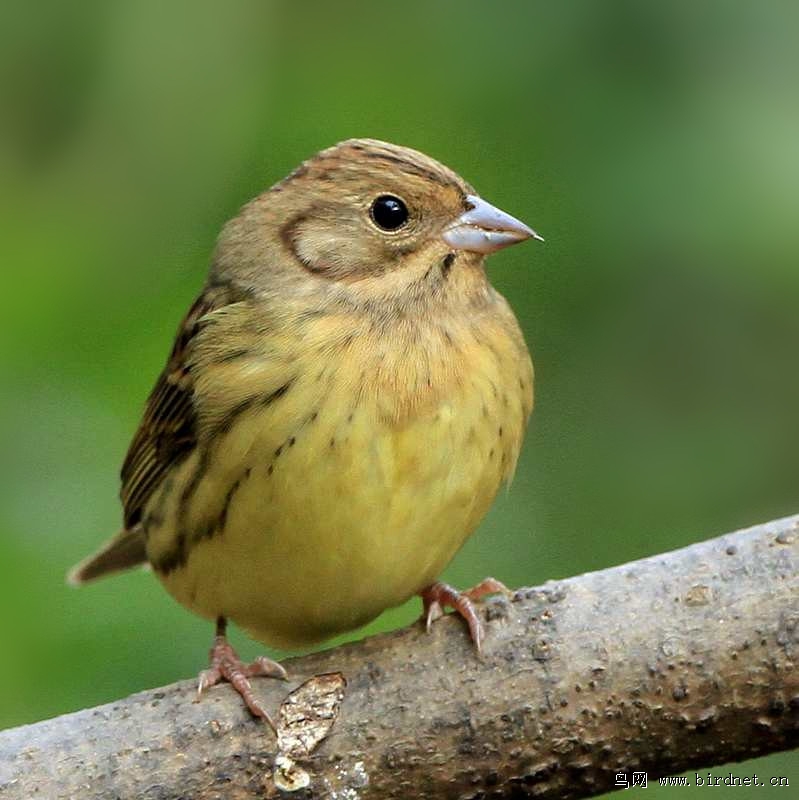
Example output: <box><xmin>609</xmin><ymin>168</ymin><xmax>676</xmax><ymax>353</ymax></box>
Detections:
<box><xmin>211</xmin><ymin>139</ymin><xmax>540</xmax><ymax>302</ymax></box>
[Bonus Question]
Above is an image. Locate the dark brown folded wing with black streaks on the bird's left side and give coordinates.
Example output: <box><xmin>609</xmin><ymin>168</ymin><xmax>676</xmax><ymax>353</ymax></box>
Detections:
<box><xmin>121</xmin><ymin>286</ymin><xmax>234</xmax><ymax>530</ymax></box>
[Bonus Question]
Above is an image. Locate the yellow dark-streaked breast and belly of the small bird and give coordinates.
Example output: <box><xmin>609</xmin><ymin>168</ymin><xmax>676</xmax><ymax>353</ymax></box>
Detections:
<box><xmin>148</xmin><ymin>301</ymin><xmax>532</xmax><ymax>646</ymax></box>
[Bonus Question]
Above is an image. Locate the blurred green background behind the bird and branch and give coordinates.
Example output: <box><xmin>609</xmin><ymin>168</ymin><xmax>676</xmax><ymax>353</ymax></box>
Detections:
<box><xmin>0</xmin><ymin>0</ymin><xmax>799</xmax><ymax>800</ymax></box>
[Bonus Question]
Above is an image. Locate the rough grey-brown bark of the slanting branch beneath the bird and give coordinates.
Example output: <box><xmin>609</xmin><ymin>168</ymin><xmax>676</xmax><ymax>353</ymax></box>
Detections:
<box><xmin>0</xmin><ymin>516</ymin><xmax>799</xmax><ymax>800</ymax></box>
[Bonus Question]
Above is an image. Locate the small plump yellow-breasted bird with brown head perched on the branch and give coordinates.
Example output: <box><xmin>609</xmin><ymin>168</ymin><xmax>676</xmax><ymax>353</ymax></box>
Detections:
<box><xmin>69</xmin><ymin>139</ymin><xmax>541</xmax><ymax>723</ymax></box>
